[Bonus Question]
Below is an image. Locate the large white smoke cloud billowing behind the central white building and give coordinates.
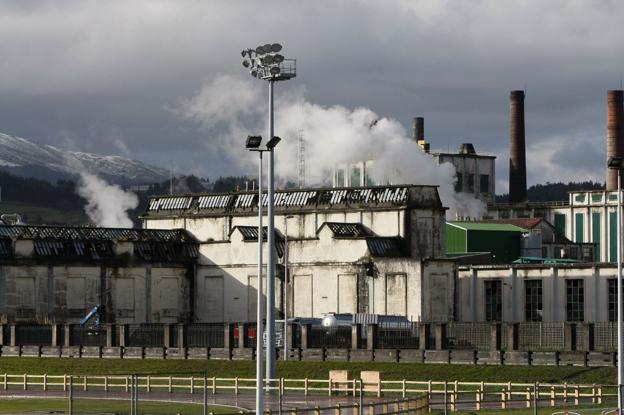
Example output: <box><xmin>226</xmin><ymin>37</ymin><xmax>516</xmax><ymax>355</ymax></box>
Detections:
<box><xmin>174</xmin><ymin>76</ymin><xmax>486</xmax><ymax>218</ymax></box>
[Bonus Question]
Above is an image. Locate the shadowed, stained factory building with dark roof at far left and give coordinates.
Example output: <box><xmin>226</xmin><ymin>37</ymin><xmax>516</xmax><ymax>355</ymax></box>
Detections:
<box><xmin>0</xmin><ymin>225</ymin><xmax>198</xmax><ymax>324</ymax></box>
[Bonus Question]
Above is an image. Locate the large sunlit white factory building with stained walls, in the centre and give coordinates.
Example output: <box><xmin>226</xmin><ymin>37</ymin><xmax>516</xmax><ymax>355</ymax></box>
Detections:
<box><xmin>142</xmin><ymin>186</ymin><xmax>455</xmax><ymax>322</ymax></box>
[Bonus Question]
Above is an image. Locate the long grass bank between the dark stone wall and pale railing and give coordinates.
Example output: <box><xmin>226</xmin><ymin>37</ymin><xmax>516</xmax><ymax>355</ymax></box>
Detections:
<box><xmin>0</xmin><ymin>357</ymin><xmax>616</xmax><ymax>384</ymax></box>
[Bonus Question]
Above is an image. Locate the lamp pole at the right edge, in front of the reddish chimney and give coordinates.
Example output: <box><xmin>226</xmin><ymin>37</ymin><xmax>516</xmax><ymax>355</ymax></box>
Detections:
<box><xmin>608</xmin><ymin>157</ymin><xmax>624</xmax><ymax>414</ymax></box>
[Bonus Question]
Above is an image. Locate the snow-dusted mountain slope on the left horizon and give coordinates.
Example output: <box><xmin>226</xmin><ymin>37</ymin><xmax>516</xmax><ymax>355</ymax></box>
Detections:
<box><xmin>0</xmin><ymin>133</ymin><xmax>168</xmax><ymax>184</ymax></box>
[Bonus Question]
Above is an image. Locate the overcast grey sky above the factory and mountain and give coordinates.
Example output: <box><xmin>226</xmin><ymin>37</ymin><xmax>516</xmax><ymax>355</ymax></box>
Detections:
<box><xmin>0</xmin><ymin>0</ymin><xmax>624</xmax><ymax>193</ymax></box>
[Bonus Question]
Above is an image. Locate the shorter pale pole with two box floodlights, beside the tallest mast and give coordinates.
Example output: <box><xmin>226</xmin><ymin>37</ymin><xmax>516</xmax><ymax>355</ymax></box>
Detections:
<box><xmin>246</xmin><ymin>136</ymin><xmax>266</xmax><ymax>414</ymax></box>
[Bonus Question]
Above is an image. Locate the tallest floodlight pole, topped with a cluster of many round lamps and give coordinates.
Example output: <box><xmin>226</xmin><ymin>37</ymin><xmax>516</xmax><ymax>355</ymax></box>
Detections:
<box><xmin>241</xmin><ymin>43</ymin><xmax>297</xmax><ymax>389</ymax></box>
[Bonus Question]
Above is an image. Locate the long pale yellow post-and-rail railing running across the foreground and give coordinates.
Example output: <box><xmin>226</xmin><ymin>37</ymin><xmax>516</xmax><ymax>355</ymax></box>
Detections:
<box><xmin>0</xmin><ymin>374</ymin><xmax>617</xmax><ymax>413</ymax></box>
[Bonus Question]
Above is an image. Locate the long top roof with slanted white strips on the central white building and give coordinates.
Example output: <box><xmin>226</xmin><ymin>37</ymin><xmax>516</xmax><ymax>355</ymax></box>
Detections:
<box><xmin>147</xmin><ymin>186</ymin><xmax>420</xmax><ymax>218</ymax></box>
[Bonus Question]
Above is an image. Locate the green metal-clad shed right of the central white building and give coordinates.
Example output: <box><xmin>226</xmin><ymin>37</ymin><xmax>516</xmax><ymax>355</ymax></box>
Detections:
<box><xmin>446</xmin><ymin>222</ymin><xmax>529</xmax><ymax>264</ymax></box>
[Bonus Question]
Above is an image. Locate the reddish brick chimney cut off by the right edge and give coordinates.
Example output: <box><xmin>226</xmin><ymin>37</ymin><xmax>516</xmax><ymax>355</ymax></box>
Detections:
<box><xmin>607</xmin><ymin>90</ymin><xmax>624</xmax><ymax>191</ymax></box>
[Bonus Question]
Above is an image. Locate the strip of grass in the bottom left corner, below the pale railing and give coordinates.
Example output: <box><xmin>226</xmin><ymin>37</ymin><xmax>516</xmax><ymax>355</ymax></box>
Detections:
<box><xmin>0</xmin><ymin>398</ymin><xmax>236</xmax><ymax>415</ymax></box>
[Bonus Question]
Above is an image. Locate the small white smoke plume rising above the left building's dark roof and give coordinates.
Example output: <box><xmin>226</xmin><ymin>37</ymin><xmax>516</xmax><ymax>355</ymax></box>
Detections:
<box><xmin>77</xmin><ymin>170</ymin><xmax>139</xmax><ymax>228</ymax></box>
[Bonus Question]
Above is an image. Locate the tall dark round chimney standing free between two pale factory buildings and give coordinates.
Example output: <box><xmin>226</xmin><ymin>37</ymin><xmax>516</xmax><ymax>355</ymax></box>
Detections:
<box><xmin>509</xmin><ymin>91</ymin><xmax>527</xmax><ymax>203</ymax></box>
